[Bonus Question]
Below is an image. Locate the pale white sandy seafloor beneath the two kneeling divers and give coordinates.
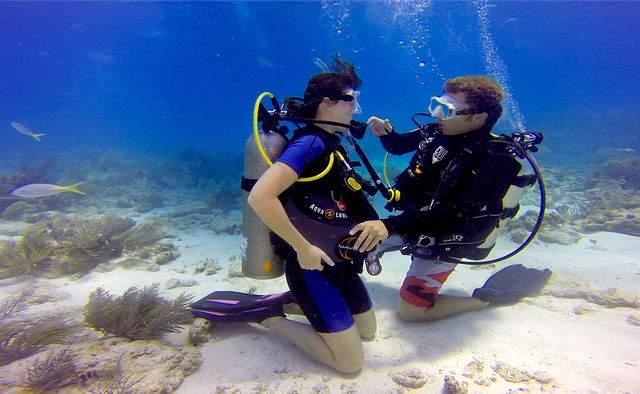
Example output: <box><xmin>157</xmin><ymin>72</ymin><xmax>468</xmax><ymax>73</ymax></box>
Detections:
<box><xmin>0</xmin><ymin>208</ymin><xmax>640</xmax><ymax>394</ymax></box>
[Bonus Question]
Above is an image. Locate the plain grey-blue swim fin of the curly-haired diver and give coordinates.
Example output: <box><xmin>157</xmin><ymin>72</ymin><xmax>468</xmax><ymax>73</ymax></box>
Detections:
<box><xmin>473</xmin><ymin>264</ymin><xmax>551</xmax><ymax>305</ymax></box>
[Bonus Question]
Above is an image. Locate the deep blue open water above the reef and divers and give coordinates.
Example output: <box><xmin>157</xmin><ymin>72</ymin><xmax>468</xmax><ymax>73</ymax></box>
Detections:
<box><xmin>0</xmin><ymin>1</ymin><xmax>640</xmax><ymax>172</ymax></box>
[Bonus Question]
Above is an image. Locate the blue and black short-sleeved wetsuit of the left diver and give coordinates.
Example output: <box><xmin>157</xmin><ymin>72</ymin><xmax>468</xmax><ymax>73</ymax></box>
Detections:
<box><xmin>275</xmin><ymin>125</ymin><xmax>377</xmax><ymax>333</ymax></box>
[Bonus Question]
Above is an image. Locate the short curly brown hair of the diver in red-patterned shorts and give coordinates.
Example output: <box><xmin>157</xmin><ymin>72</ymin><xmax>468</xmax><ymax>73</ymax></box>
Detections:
<box><xmin>444</xmin><ymin>75</ymin><xmax>504</xmax><ymax>129</ymax></box>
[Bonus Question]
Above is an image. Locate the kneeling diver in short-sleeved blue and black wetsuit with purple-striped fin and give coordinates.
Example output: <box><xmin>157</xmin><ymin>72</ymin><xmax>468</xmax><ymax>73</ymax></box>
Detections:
<box><xmin>192</xmin><ymin>56</ymin><xmax>378</xmax><ymax>373</ymax></box>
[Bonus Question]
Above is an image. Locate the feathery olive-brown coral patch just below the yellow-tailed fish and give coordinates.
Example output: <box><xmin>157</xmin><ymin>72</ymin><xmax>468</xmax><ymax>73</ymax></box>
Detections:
<box><xmin>0</xmin><ymin>215</ymin><xmax>172</xmax><ymax>278</ymax></box>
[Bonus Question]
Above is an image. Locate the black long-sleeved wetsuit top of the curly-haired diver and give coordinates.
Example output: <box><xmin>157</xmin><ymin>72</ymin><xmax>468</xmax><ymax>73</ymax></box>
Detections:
<box><xmin>381</xmin><ymin>123</ymin><xmax>521</xmax><ymax>258</ymax></box>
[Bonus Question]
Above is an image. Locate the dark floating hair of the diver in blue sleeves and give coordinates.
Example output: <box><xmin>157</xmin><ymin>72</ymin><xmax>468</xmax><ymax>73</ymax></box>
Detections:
<box><xmin>289</xmin><ymin>53</ymin><xmax>362</xmax><ymax>118</ymax></box>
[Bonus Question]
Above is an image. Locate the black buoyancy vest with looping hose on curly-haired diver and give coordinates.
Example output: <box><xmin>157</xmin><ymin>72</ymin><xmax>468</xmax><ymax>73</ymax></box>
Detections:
<box><xmin>390</xmin><ymin>127</ymin><xmax>546</xmax><ymax>264</ymax></box>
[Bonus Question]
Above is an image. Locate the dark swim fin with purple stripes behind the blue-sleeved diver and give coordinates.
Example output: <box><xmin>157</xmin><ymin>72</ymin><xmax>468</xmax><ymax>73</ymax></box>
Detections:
<box><xmin>191</xmin><ymin>291</ymin><xmax>295</xmax><ymax>323</ymax></box>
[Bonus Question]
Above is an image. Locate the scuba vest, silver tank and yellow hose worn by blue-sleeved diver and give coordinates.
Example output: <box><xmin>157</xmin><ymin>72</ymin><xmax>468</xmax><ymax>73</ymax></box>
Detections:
<box><xmin>241</xmin><ymin>92</ymin><xmax>386</xmax><ymax>279</ymax></box>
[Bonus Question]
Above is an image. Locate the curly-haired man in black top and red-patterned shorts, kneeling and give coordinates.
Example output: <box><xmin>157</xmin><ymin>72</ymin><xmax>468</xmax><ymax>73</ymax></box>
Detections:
<box><xmin>352</xmin><ymin>76</ymin><xmax>551</xmax><ymax>321</ymax></box>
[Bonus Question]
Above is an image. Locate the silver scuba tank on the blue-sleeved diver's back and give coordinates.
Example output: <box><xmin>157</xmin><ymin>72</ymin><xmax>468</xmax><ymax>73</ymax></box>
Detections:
<box><xmin>242</xmin><ymin>131</ymin><xmax>287</xmax><ymax>279</ymax></box>
